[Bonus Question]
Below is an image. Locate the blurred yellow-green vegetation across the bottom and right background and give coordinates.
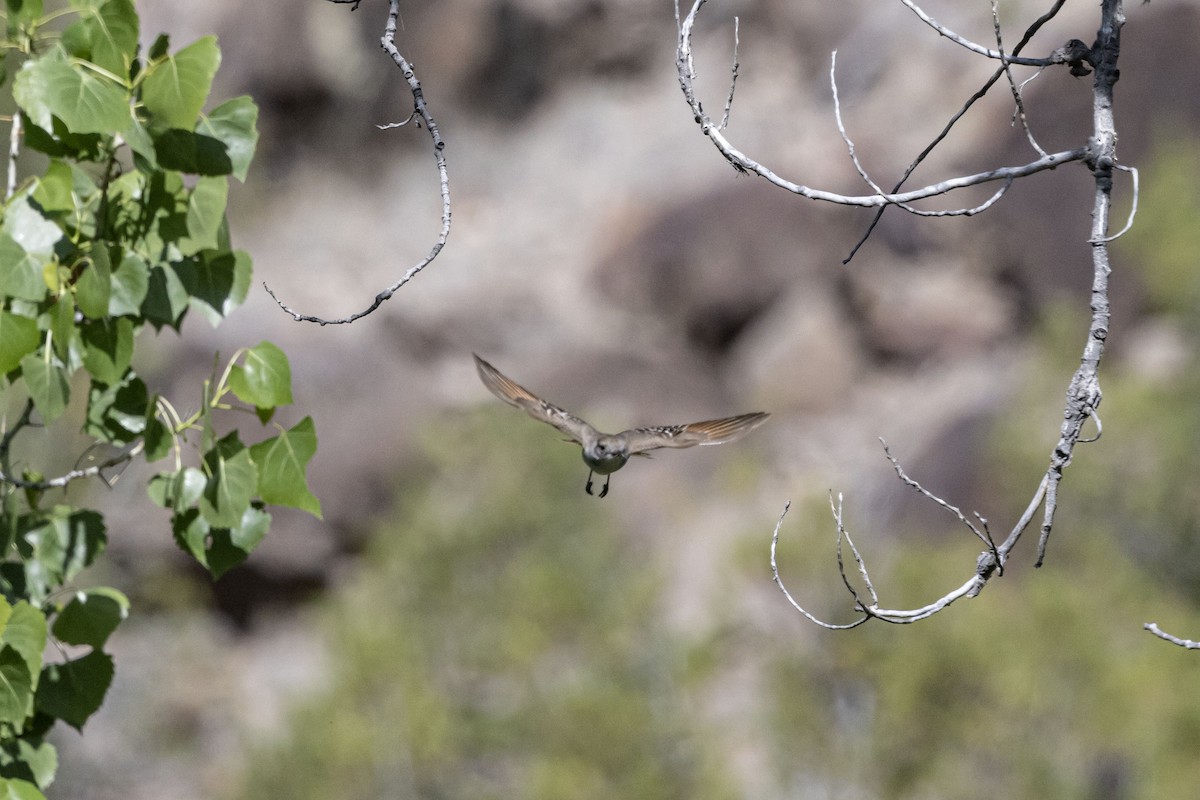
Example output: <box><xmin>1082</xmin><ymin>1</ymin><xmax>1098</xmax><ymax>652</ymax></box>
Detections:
<box><xmin>226</xmin><ymin>143</ymin><xmax>1200</xmax><ymax>800</ymax></box>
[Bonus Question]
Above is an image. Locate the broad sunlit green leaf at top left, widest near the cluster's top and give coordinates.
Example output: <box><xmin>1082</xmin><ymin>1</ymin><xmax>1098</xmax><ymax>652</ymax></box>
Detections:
<box><xmin>12</xmin><ymin>47</ymin><xmax>132</xmax><ymax>133</ymax></box>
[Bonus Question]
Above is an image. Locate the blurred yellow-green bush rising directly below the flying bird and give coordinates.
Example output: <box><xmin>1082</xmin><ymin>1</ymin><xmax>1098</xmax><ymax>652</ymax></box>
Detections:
<box><xmin>230</xmin><ymin>411</ymin><xmax>734</xmax><ymax>800</ymax></box>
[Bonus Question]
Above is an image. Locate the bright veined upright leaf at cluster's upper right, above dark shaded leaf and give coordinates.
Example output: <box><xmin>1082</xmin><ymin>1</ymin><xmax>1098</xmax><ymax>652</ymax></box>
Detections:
<box><xmin>142</xmin><ymin>36</ymin><xmax>221</xmax><ymax>131</ymax></box>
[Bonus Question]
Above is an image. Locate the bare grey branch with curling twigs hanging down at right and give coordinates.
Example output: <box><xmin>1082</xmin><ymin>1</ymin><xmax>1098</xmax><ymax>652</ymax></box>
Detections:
<box><xmin>734</xmin><ymin>0</ymin><xmax>1128</xmax><ymax>623</ymax></box>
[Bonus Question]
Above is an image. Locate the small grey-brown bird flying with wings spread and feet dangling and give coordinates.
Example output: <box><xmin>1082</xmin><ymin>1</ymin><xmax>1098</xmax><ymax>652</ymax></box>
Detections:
<box><xmin>472</xmin><ymin>353</ymin><xmax>770</xmax><ymax>498</ymax></box>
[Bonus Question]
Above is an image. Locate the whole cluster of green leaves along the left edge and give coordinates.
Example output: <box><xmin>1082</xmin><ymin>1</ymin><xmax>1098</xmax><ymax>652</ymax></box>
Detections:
<box><xmin>0</xmin><ymin>0</ymin><xmax>320</xmax><ymax>798</ymax></box>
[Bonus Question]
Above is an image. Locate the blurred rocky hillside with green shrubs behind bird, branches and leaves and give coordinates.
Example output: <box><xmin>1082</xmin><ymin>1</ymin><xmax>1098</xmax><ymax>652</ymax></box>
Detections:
<box><xmin>46</xmin><ymin>0</ymin><xmax>1200</xmax><ymax>800</ymax></box>
